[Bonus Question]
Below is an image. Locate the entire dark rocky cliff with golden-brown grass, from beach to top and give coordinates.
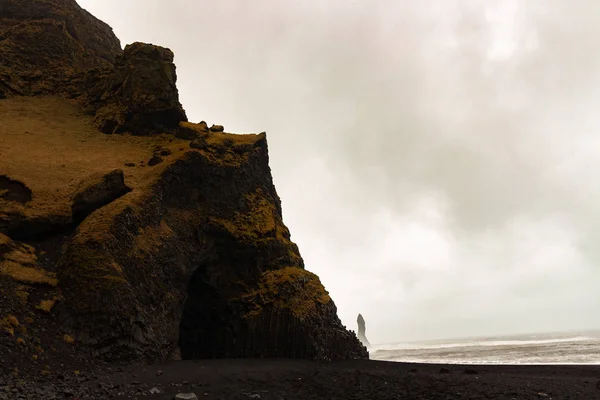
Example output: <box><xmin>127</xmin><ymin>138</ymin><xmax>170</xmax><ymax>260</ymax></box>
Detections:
<box><xmin>0</xmin><ymin>0</ymin><xmax>368</xmax><ymax>374</ymax></box>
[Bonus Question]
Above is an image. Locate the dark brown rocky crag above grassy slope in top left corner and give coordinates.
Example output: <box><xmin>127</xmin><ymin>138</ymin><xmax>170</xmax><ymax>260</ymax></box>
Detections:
<box><xmin>0</xmin><ymin>0</ymin><xmax>121</xmax><ymax>97</ymax></box>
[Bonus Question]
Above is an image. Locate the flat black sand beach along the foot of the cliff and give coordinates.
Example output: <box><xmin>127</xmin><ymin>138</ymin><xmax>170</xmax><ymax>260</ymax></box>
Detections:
<box><xmin>0</xmin><ymin>360</ymin><xmax>600</xmax><ymax>400</ymax></box>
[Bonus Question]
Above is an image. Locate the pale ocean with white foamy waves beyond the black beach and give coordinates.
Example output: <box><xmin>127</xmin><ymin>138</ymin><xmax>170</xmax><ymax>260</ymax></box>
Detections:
<box><xmin>369</xmin><ymin>331</ymin><xmax>600</xmax><ymax>365</ymax></box>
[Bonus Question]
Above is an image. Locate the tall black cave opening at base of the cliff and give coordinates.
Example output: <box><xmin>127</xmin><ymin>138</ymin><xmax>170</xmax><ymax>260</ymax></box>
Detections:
<box><xmin>179</xmin><ymin>267</ymin><xmax>232</xmax><ymax>360</ymax></box>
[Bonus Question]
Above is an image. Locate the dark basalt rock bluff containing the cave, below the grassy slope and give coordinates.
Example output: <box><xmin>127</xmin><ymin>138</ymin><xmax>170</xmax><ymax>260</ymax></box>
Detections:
<box><xmin>58</xmin><ymin>133</ymin><xmax>367</xmax><ymax>359</ymax></box>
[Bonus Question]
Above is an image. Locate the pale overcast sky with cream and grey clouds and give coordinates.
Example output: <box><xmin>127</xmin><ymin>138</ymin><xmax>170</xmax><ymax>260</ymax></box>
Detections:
<box><xmin>79</xmin><ymin>0</ymin><xmax>600</xmax><ymax>343</ymax></box>
